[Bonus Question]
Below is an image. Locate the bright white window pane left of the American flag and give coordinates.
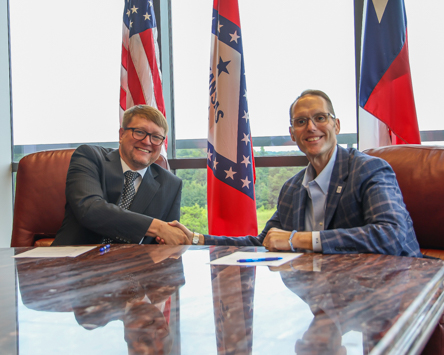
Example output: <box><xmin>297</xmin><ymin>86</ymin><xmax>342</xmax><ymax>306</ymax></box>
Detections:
<box><xmin>9</xmin><ymin>0</ymin><xmax>123</xmax><ymax>149</ymax></box>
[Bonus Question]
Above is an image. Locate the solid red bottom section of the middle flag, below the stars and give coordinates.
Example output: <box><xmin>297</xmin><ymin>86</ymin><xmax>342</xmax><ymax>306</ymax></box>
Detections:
<box><xmin>207</xmin><ymin>166</ymin><xmax>258</xmax><ymax>237</ymax></box>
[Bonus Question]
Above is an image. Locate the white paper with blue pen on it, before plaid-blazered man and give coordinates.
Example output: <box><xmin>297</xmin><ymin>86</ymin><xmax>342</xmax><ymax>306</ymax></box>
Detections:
<box><xmin>210</xmin><ymin>251</ymin><xmax>302</xmax><ymax>266</ymax></box>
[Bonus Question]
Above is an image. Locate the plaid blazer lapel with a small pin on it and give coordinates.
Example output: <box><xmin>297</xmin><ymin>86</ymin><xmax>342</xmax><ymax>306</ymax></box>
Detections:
<box><xmin>325</xmin><ymin>145</ymin><xmax>350</xmax><ymax>229</ymax></box>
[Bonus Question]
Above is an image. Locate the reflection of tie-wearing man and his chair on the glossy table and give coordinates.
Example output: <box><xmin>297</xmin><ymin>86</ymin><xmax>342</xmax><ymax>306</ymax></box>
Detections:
<box><xmin>17</xmin><ymin>247</ymin><xmax>186</xmax><ymax>354</ymax></box>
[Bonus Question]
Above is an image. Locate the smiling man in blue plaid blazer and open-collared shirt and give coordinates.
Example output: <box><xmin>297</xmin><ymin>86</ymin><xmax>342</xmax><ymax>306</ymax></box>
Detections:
<box><xmin>165</xmin><ymin>90</ymin><xmax>422</xmax><ymax>257</ymax></box>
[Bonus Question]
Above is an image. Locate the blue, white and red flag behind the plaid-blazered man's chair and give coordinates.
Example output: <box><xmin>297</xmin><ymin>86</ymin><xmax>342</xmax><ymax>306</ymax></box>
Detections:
<box><xmin>359</xmin><ymin>0</ymin><xmax>421</xmax><ymax>149</ymax></box>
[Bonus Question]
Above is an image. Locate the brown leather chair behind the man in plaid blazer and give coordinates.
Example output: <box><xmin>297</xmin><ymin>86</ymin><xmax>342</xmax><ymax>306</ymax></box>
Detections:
<box><xmin>364</xmin><ymin>144</ymin><xmax>444</xmax><ymax>259</ymax></box>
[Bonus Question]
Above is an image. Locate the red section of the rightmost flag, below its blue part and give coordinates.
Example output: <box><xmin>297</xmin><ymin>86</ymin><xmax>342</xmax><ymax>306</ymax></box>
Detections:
<box><xmin>364</xmin><ymin>37</ymin><xmax>421</xmax><ymax>144</ymax></box>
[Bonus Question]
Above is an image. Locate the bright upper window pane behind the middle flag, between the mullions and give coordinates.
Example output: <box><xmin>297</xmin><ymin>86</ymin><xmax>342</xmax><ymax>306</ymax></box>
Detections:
<box><xmin>172</xmin><ymin>0</ymin><xmax>356</xmax><ymax>145</ymax></box>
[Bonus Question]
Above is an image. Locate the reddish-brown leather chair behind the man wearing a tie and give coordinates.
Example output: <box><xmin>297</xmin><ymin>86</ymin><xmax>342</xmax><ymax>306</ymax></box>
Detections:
<box><xmin>11</xmin><ymin>149</ymin><xmax>170</xmax><ymax>247</ymax></box>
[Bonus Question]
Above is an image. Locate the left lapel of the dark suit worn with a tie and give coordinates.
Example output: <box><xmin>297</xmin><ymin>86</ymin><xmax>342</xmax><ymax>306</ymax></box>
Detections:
<box><xmin>105</xmin><ymin>149</ymin><xmax>124</xmax><ymax>204</ymax></box>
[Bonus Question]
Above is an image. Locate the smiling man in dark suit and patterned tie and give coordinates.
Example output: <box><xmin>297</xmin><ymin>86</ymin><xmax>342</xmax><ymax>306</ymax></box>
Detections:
<box><xmin>52</xmin><ymin>105</ymin><xmax>189</xmax><ymax>245</ymax></box>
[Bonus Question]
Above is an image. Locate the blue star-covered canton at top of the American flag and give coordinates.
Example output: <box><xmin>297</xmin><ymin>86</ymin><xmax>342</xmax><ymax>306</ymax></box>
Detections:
<box><xmin>123</xmin><ymin>0</ymin><xmax>157</xmax><ymax>37</ymax></box>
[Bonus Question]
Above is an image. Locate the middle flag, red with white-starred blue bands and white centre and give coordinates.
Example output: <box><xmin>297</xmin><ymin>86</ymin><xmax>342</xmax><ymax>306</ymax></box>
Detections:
<box><xmin>207</xmin><ymin>0</ymin><xmax>257</xmax><ymax>236</ymax></box>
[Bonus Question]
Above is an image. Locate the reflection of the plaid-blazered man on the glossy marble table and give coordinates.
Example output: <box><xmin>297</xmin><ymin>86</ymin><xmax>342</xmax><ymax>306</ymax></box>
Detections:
<box><xmin>275</xmin><ymin>255</ymin><xmax>415</xmax><ymax>355</ymax></box>
